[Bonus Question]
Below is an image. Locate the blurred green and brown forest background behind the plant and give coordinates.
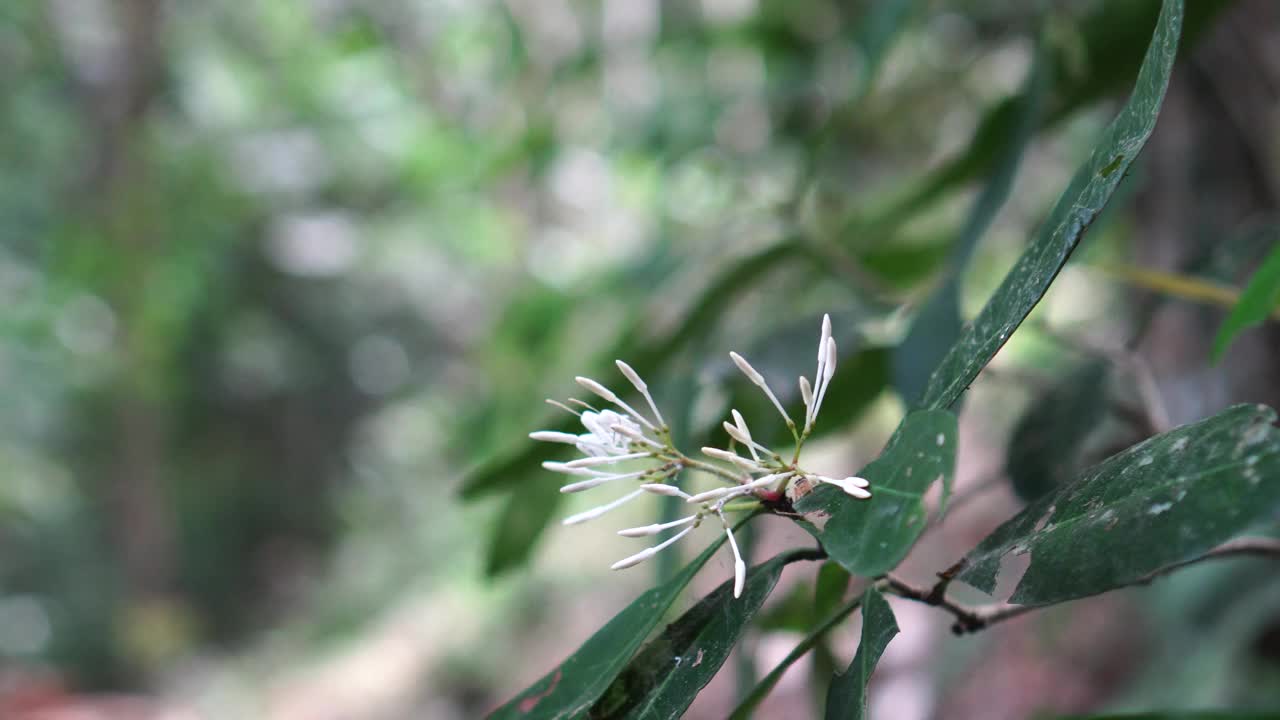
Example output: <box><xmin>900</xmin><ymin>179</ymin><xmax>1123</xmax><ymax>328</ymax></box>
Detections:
<box><xmin>0</xmin><ymin>0</ymin><xmax>1280</xmax><ymax>720</ymax></box>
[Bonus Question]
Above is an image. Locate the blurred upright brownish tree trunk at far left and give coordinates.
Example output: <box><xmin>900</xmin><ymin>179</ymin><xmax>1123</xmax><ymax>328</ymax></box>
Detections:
<box><xmin>51</xmin><ymin>0</ymin><xmax>174</xmax><ymax>605</ymax></box>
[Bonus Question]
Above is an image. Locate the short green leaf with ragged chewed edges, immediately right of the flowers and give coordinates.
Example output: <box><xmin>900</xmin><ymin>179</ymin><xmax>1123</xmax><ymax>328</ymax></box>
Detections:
<box><xmin>794</xmin><ymin>410</ymin><xmax>956</xmax><ymax>577</ymax></box>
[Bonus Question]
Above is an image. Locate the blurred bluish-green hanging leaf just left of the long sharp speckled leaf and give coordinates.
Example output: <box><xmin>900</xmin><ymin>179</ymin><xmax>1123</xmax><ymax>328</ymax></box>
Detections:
<box><xmin>893</xmin><ymin>37</ymin><xmax>1050</xmax><ymax>402</ymax></box>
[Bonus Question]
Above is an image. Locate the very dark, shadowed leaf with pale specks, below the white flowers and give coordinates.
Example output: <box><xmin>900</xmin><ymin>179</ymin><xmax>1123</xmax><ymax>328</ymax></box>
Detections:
<box><xmin>589</xmin><ymin>550</ymin><xmax>813</xmax><ymax>720</ymax></box>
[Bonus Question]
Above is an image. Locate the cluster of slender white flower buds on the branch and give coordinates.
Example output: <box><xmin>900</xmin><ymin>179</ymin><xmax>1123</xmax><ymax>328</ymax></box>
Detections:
<box><xmin>529</xmin><ymin>315</ymin><xmax>870</xmax><ymax>597</ymax></box>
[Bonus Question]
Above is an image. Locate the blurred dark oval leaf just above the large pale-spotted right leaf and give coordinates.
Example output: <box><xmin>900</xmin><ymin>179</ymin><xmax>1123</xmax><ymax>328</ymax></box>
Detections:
<box><xmin>1005</xmin><ymin>360</ymin><xmax>1107</xmax><ymax>501</ymax></box>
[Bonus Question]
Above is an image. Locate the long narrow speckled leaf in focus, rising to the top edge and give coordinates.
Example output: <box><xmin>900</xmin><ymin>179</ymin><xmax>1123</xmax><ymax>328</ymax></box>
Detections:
<box><xmin>919</xmin><ymin>0</ymin><xmax>1183</xmax><ymax>409</ymax></box>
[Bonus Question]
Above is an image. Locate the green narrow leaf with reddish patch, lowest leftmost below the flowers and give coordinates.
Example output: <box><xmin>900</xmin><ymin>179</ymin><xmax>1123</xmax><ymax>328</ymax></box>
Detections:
<box><xmin>489</xmin><ymin>525</ymin><xmax>732</xmax><ymax>720</ymax></box>
